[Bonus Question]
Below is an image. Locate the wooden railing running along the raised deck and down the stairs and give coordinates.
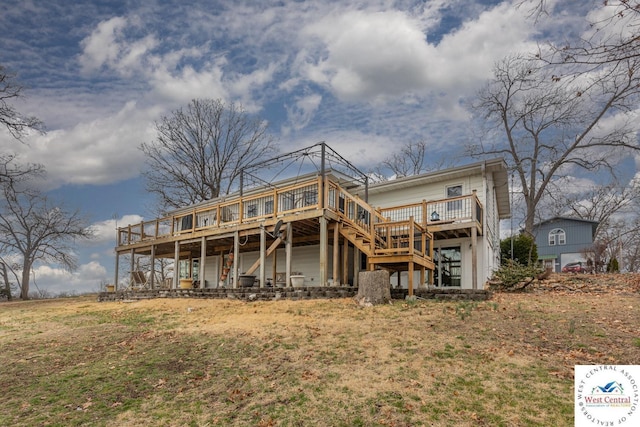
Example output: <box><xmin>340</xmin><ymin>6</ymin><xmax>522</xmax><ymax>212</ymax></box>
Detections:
<box><xmin>117</xmin><ymin>177</ymin><xmax>482</xmax><ymax>253</ymax></box>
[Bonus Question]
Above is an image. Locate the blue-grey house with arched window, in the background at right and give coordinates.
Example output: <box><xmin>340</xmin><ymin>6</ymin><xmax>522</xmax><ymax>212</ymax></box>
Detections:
<box><xmin>533</xmin><ymin>217</ymin><xmax>599</xmax><ymax>272</ymax></box>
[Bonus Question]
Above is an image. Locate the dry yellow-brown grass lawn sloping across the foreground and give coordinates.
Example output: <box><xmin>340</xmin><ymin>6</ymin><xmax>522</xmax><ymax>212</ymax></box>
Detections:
<box><xmin>0</xmin><ymin>276</ymin><xmax>640</xmax><ymax>426</ymax></box>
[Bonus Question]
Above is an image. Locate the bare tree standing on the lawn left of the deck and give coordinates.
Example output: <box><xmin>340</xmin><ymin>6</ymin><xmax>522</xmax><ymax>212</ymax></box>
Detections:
<box><xmin>0</xmin><ymin>176</ymin><xmax>93</xmax><ymax>299</ymax></box>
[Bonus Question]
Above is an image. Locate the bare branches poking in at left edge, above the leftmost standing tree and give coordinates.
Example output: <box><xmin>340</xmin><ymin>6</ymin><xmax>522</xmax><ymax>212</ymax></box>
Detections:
<box><xmin>0</xmin><ymin>65</ymin><xmax>43</xmax><ymax>140</ymax></box>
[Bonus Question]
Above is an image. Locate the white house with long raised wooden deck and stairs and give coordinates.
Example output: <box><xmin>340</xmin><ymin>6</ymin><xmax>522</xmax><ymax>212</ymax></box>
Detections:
<box><xmin>115</xmin><ymin>143</ymin><xmax>510</xmax><ymax>294</ymax></box>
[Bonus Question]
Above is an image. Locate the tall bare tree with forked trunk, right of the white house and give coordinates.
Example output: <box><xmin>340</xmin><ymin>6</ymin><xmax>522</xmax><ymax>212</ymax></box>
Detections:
<box><xmin>469</xmin><ymin>52</ymin><xmax>640</xmax><ymax>237</ymax></box>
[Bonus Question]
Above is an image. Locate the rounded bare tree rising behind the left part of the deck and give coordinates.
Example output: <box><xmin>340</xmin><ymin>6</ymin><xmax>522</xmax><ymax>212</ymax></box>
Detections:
<box><xmin>140</xmin><ymin>99</ymin><xmax>276</xmax><ymax>209</ymax></box>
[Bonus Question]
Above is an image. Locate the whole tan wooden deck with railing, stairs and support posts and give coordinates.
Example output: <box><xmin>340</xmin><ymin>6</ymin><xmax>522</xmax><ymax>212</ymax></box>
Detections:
<box><xmin>115</xmin><ymin>176</ymin><xmax>482</xmax><ymax>296</ymax></box>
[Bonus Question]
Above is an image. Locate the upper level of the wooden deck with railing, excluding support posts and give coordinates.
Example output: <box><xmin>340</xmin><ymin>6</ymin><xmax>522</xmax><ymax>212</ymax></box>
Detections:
<box><xmin>116</xmin><ymin>175</ymin><xmax>483</xmax><ymax>252</ymax></box>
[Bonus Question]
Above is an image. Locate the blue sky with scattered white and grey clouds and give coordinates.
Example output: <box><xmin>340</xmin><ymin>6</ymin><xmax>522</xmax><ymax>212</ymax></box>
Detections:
<box><xmin>0</xmin><ymin>0</ymin><xmax>620</xmax><ymax>293</ymax></box>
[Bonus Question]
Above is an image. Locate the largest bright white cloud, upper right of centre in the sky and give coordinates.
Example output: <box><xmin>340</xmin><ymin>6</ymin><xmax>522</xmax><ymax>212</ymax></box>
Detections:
<box><xmin>290</xmin><ymin>2</ymin><xmax>536</xmax><ymax>122</ymax></box>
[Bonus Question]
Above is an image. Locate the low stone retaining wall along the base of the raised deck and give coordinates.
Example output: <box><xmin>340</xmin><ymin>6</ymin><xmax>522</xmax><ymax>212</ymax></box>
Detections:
<box><xmin>98</xmin><ymin>287</ymin><xmax>491</xmax><ymax>301</ymax></box>
